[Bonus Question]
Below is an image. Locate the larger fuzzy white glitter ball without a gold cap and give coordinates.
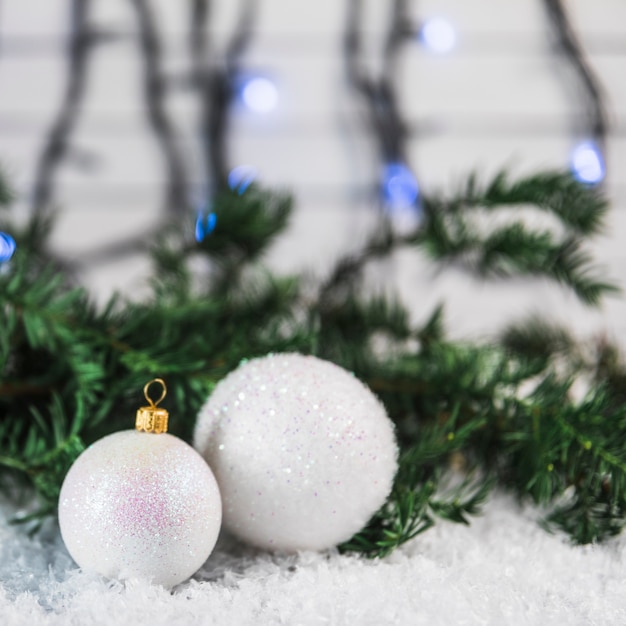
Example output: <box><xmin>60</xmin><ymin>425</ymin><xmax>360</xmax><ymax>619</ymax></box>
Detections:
<box><xmin>194</xmin><ymin>354</ymin><xmax>397</xmax><ymax>551</ymax></box>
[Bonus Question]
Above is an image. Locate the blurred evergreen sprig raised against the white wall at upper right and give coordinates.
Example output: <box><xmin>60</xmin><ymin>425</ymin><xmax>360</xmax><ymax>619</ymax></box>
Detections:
<box><xmin>417</xmin><ymin>173</ymin><xmax>617</xmax><ymax>305</ymax></box>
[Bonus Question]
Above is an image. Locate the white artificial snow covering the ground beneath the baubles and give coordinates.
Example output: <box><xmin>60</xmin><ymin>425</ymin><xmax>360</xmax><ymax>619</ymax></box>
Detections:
<box><xmin>0</xmin><ymin>494</ymin><xmax>626</xmax><ymax>626</ymax></box>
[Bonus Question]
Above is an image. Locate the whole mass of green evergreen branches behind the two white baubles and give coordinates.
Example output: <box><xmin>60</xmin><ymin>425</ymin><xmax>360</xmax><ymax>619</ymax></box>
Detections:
<box><xmin>0</xmin><ymin>162</ymin><xmax>626</xmax><ymax>556</ymax></box>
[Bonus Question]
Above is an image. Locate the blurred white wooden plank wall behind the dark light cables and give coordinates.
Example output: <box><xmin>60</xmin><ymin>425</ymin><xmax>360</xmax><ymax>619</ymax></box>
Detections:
<box><xmin>0</xmin><ymin>0</ymin><xmax>626</xmax><ymax>345</ymax></box>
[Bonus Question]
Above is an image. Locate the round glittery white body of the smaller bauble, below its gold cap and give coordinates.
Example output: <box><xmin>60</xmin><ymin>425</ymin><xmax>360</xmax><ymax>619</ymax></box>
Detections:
<box><xmin>59</xmin><ymin>430</ymin><xmax>222</xmax><ymax>587</ymax></box>
